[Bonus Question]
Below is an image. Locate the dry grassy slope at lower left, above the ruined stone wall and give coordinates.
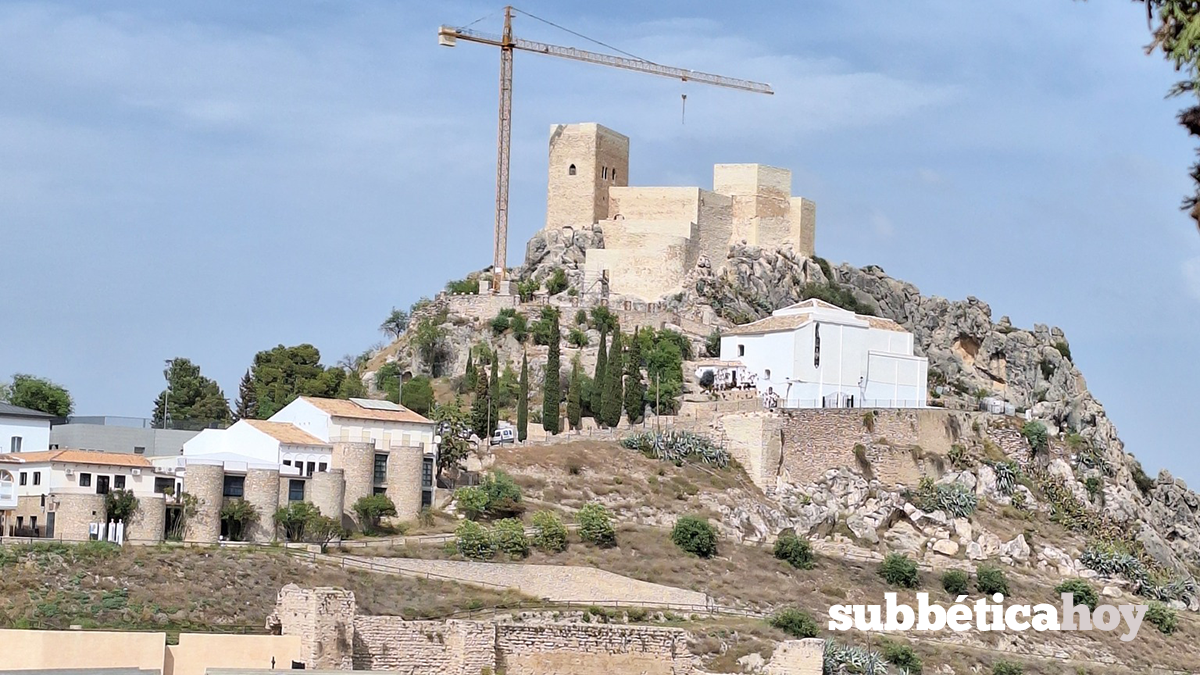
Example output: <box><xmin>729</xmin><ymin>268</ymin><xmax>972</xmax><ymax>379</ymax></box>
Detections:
<box><xmin>0</xmin><ymin>535</ymin><xmax>525</xmax><ymax>632</ymax></box>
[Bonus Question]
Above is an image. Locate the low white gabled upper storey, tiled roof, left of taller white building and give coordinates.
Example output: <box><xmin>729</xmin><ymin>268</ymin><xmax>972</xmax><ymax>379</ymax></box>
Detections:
<box><xmin>177</xmin><ymin>419</ymin><xmax>334</xmax><ymax>476</ymax></box>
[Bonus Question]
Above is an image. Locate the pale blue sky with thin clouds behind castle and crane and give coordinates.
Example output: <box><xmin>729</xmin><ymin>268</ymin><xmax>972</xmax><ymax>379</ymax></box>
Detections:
<box><xmin>0</xmin><ymin>0</ymin><xmax>1200</xmax><ymax>484</ymax></box>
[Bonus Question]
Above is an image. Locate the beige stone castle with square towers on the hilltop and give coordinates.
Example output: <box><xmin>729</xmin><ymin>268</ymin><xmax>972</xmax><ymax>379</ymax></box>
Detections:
<box><xmin>546</xmin><ymin>124</ymin><xmax>816</xmax><ymax>301</ymax></box>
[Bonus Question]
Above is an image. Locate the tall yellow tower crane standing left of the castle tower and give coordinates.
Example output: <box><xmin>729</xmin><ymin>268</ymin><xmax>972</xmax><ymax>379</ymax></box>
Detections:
<box><xmin>438</xmin><ymin>6</ymin><xmax>774</xmax><ymax>293</ymax></box>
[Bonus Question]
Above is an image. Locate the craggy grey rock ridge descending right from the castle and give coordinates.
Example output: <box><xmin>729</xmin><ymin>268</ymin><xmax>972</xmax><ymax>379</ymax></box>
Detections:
<box><xmin>677</xmin><ymin>245</ymin><xmax>1200</xmax><ymax>567</ymax></box>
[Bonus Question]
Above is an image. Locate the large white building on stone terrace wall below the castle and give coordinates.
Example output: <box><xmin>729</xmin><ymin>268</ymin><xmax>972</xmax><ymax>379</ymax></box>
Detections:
<box><xmin>720</xmin><ymin>299</ymin><xmax>929</xmax><ymax>407</ymax></box>
